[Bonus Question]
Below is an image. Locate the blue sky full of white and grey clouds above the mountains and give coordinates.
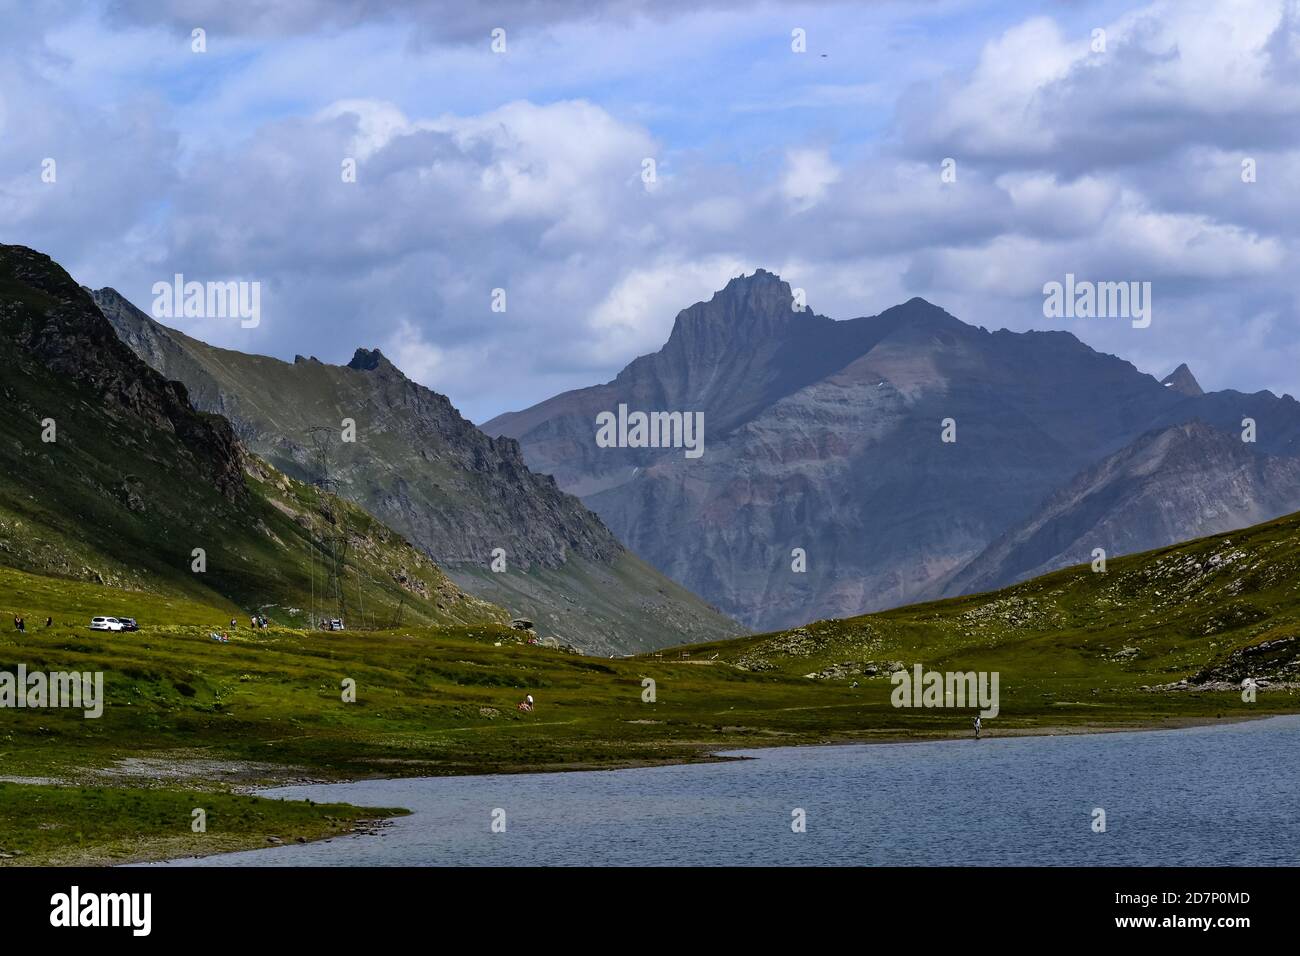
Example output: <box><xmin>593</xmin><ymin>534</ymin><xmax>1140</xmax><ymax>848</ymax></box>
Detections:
<box><xmin>0</xmin><ymin>0</ymin><xmax>1300</xmax><ymax>421</ymax></box>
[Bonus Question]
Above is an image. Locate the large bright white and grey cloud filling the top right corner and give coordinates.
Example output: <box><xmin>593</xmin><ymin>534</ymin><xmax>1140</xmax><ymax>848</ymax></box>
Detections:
<box><xmin>900</xmin><ymin>0</ymin><xmax>1300</xmax><ymax>165</ymax></box>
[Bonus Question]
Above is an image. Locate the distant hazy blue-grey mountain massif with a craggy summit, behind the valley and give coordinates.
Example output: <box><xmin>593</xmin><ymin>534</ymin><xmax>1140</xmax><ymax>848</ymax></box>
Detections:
<box><xmin>484</xmin><ymin>269</ymin><xmax>1300</xmax><ymax>630</ymax></box>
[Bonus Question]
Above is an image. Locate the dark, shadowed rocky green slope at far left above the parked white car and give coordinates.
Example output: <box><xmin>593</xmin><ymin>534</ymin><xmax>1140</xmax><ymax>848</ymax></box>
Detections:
<box><xmin>0</xmin><ymin>246</ymin><xmax>508</xmax><ymax>626</ymax></box>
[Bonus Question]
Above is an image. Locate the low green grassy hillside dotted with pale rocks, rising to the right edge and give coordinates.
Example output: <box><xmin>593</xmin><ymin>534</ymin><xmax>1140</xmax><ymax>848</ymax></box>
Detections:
<box><xmin>701</xmin><ymin>502</ymin><xmax>1300</xmax><ymax>697</ymax></box>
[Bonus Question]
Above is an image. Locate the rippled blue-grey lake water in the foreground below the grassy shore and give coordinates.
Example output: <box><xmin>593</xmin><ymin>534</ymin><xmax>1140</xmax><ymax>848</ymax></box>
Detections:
<box><xmin>149</xmin><ymin>717</ymin><xmax>1300</xmax><ymax>866</ymax></box>
